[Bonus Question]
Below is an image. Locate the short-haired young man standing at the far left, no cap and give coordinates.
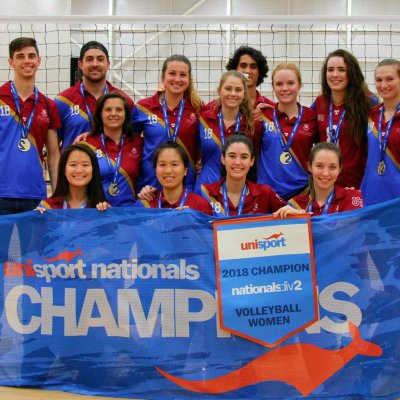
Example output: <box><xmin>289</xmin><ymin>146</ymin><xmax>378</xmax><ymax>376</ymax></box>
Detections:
<box><xmin>0</xmin><ymin>37</ymin><xmax>61</xmax><ymax>215</ymax></box>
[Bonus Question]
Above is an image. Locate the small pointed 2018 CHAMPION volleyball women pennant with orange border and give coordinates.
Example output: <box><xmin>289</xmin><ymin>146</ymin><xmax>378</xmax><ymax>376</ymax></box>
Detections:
<box><xmin>213</xmin><ymin>214</ymin><xmax>318</xmax><ymax>347</ymax></box>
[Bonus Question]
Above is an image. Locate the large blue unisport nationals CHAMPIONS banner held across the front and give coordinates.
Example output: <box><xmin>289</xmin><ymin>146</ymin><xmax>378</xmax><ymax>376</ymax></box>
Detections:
<box><xmin>0</xmin><ymin>205</ymin><xmax>400</xmax><ymax>400</ymax></box>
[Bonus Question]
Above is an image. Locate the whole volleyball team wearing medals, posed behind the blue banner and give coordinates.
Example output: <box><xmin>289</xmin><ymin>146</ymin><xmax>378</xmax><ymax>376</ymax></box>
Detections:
<box><xmin>0</xmin><ymin>38</ymin><xmax>400</xmax><ymax>218</ymax></box>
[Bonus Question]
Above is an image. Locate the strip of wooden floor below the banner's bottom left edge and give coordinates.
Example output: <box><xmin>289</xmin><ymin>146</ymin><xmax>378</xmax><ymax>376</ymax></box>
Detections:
<box><xmin>0</xmin><ymin>387</ymin><xmax>142</xmax><ymax>400</ymax></box>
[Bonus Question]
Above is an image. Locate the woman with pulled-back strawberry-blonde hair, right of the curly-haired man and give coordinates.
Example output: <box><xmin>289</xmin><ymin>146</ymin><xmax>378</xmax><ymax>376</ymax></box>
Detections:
<box><xmin>258</xmin><ymin>63</ymin><xmax>318</xmax><ymax>200</ymax></box>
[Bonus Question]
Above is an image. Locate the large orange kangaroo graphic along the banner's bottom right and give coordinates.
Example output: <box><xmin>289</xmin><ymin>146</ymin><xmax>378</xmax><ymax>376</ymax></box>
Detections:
<box><xmin>156</xmin><ymin>322</ymin><xmax>382</xmax><ymax>396</ymax></box>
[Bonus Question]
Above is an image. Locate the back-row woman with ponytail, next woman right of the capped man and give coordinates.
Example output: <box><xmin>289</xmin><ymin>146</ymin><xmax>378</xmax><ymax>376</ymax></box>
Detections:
<box><xmin>132</xmin><ymin>54</ymin><xmax>203</xmax><ymax>190</ymax></box>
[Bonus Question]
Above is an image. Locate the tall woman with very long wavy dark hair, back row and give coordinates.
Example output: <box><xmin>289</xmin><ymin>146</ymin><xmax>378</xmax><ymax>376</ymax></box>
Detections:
<box><xmin>312</xmin><ymin>49</ymin><xmax>378</xmax><ymax>189</ymax></box>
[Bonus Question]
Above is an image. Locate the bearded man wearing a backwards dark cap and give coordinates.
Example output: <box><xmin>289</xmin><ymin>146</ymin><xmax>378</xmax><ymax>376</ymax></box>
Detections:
<box><xmin>55</xmin><ymin>41</ymin><xmax>133</xmax><ymax>149</ymax></box>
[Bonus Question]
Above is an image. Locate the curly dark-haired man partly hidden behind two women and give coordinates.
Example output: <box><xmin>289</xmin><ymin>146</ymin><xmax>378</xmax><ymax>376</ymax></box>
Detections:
<box><xmin>226</xmin><ymin>46</ymin><xmax>275</xmax><ymax>108</ymax></box>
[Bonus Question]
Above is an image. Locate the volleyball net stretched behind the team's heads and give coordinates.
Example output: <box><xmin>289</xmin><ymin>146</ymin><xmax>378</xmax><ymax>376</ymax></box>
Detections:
<box><xmin>0</xmin><ymin>16</ymin><xmax>400</xmax><ymax>105</ymax></box>
